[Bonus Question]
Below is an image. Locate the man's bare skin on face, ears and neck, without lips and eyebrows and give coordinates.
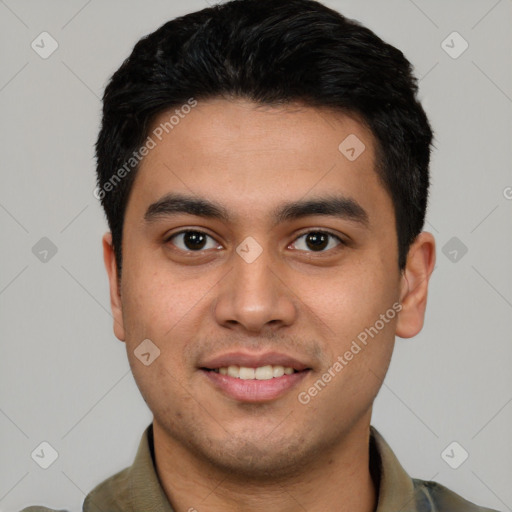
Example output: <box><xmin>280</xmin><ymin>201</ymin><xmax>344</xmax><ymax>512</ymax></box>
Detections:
<box><xmin>103</xmin><ymin>99</ymin><xmax>435</xmax><ymax>512</ymax></box>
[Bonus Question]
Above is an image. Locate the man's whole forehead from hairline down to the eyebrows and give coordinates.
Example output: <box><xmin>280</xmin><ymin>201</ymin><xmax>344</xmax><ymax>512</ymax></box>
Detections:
<box><xmin>126</xmin><ymin>99</ymin><xmax>390</xmax><ymax>226</ymax></box>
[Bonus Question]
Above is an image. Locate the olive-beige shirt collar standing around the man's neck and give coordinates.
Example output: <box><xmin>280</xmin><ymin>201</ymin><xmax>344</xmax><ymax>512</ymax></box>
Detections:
<box><xmin>111</xmin><ymin>423</ymin><xmax>417</xmax><ymax>512</ymax></box>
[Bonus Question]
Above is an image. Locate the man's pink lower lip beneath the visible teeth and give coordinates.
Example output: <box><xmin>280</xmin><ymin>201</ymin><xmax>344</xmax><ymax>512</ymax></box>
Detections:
<box><xmin>200</xmin><ymin>370</ymin><xmax>309</xmax><ymax>402</ymax></box>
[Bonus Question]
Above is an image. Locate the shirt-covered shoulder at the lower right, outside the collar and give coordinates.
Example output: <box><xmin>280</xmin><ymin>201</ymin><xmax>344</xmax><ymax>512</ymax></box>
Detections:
<box><xmin>412</xmin><ymin>478</ymin><xmax>498</xmax><ymax>512</ymax></box>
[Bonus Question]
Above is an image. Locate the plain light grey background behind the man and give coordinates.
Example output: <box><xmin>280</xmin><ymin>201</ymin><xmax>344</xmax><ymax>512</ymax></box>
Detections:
<box><xmin>0</xmin><ymin>0</ymin><xmax>512</xmax><ymax>511</ymax></box>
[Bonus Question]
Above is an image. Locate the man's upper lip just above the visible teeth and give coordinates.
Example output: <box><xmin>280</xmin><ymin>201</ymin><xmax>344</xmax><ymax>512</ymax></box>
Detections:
<box><xmin>199</xmin><ymin>351</ymin><xmax>309</xmax><ymax>371</ymax></box>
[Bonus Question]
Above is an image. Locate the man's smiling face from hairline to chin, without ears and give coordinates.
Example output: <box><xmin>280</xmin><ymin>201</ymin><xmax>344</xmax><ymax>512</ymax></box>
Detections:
<box><xmin>108</xmin><ymin>99</ymin><xmax>401</xmax><ymax>475</ymax></box>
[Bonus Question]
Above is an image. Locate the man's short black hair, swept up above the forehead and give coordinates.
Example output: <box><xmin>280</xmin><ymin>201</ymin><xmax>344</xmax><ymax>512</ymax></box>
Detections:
<box><xmin>95</xmin><ymin>0</ymin><xmax>433</xmax><ymax>275</ymax></box>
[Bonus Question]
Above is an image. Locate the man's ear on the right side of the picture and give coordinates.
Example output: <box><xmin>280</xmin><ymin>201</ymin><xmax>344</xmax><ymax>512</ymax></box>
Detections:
<box><xmin>396</xmin><ymin>231</ymin><xmax>436</xmax><ymax>338</ymax></box>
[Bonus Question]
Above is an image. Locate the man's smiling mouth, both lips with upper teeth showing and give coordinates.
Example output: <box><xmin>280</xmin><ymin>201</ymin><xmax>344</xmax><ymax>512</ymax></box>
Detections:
<box><xmin>198</xmin><ymin>353</ymin><xmax>312</xmax><ymax>402</ymax></box>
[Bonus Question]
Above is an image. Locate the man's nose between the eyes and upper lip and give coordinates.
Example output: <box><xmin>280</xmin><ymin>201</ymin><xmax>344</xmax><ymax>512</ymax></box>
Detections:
<box><xmin>214</xmin><ymin>242</ymin><xmax>297</xmax><ymax>333</ymax></box>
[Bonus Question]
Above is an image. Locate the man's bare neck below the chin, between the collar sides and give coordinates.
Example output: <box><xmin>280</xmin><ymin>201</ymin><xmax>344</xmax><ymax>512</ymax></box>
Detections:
<box><xmin>153</xmin><ymin>418</ymin><xmax>377</xmax><ymax>512</ymax></box>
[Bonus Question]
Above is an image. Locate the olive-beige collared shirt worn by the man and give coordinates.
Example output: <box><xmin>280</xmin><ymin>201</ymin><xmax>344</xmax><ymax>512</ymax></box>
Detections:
<box><xmin>21</xmin><ymin>424</ymin><xmax>497</xmax><ymax>512</ymax></box>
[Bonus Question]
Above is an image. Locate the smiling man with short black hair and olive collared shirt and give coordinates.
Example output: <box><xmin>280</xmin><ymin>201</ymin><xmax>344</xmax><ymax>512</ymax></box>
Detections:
<box><xmin>25</xmin><ymin>0</ymin><xmax>498</xmax><ymax>512</ymax></box>
